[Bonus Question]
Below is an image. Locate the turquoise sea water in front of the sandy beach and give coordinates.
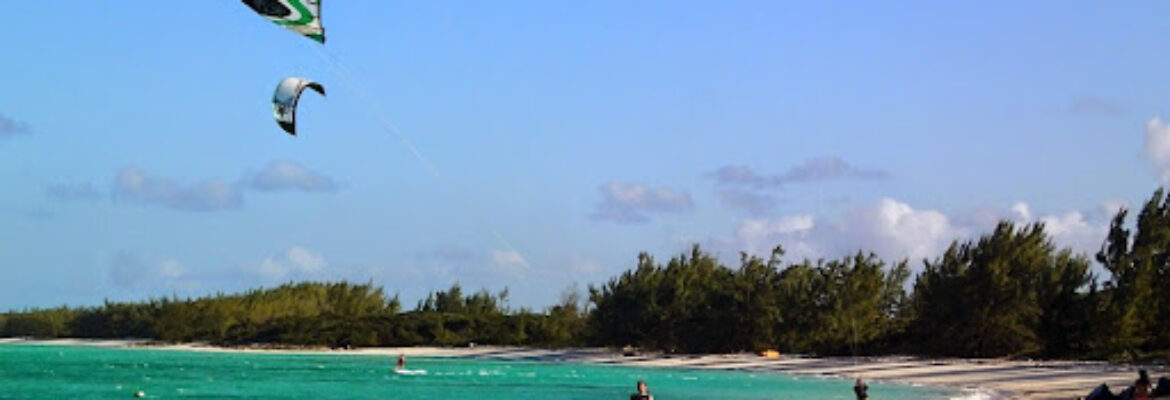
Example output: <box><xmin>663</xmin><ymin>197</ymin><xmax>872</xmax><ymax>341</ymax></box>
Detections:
<box><xmin>0</xmin><ymin>345</ymin><xmax>955</xmax><ymax>400</ymax></box>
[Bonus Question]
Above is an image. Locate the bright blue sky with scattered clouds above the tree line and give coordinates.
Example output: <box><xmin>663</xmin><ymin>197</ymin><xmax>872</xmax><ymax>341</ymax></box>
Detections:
<box><xmin>0</xmin><ymin>0</ymin><xmax>1170</xmax><ymax>308</ymax></box>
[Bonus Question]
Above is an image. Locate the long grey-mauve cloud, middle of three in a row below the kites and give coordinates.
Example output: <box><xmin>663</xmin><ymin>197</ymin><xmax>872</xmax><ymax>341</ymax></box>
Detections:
<box><xmin>113</xmin><ymin>166</ymin><xmax>243</xmax><ymax>212</ymax></box>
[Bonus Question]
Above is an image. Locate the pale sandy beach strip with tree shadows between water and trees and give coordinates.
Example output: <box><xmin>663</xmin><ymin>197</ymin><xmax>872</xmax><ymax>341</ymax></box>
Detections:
<box><xmin>0</xmin><ymin>338</ymin><xmax>1170</xmax><ymax>400</ymax></box>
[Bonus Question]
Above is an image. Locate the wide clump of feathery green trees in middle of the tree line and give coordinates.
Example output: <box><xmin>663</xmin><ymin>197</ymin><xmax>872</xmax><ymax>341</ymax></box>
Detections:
<box><xmin>587</xmin><ymin>246</ymin><xmax>908</xmax><ymax>354</ymax></box>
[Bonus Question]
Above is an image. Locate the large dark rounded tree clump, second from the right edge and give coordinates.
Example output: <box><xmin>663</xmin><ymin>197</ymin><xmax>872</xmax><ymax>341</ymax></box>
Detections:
<box><xmin>913</xmin><ymin>222</ymin><xmax>1088</xmax><ymax>357</ymax></box>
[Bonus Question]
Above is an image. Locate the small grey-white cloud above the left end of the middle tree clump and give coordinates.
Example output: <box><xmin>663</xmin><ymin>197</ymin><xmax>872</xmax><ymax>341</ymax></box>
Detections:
<box><xmin>590</xmin><ymin>182</ymin><xmax>694</xmax><ymax>223</ymax></box>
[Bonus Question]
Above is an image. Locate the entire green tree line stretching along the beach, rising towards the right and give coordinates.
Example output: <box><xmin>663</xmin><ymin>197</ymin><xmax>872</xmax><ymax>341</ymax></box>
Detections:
<box><xmin>0</xmin><ymin>189</ymin><xmax>1170</xmax><ymax>360</ymax></box>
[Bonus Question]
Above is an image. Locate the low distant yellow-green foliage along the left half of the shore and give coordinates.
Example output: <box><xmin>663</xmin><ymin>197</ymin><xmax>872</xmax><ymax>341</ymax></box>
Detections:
<box><xmin>0</xmin><ymin>282</ymin><xmax>584</xmax><ymax>347</ymax></box>
